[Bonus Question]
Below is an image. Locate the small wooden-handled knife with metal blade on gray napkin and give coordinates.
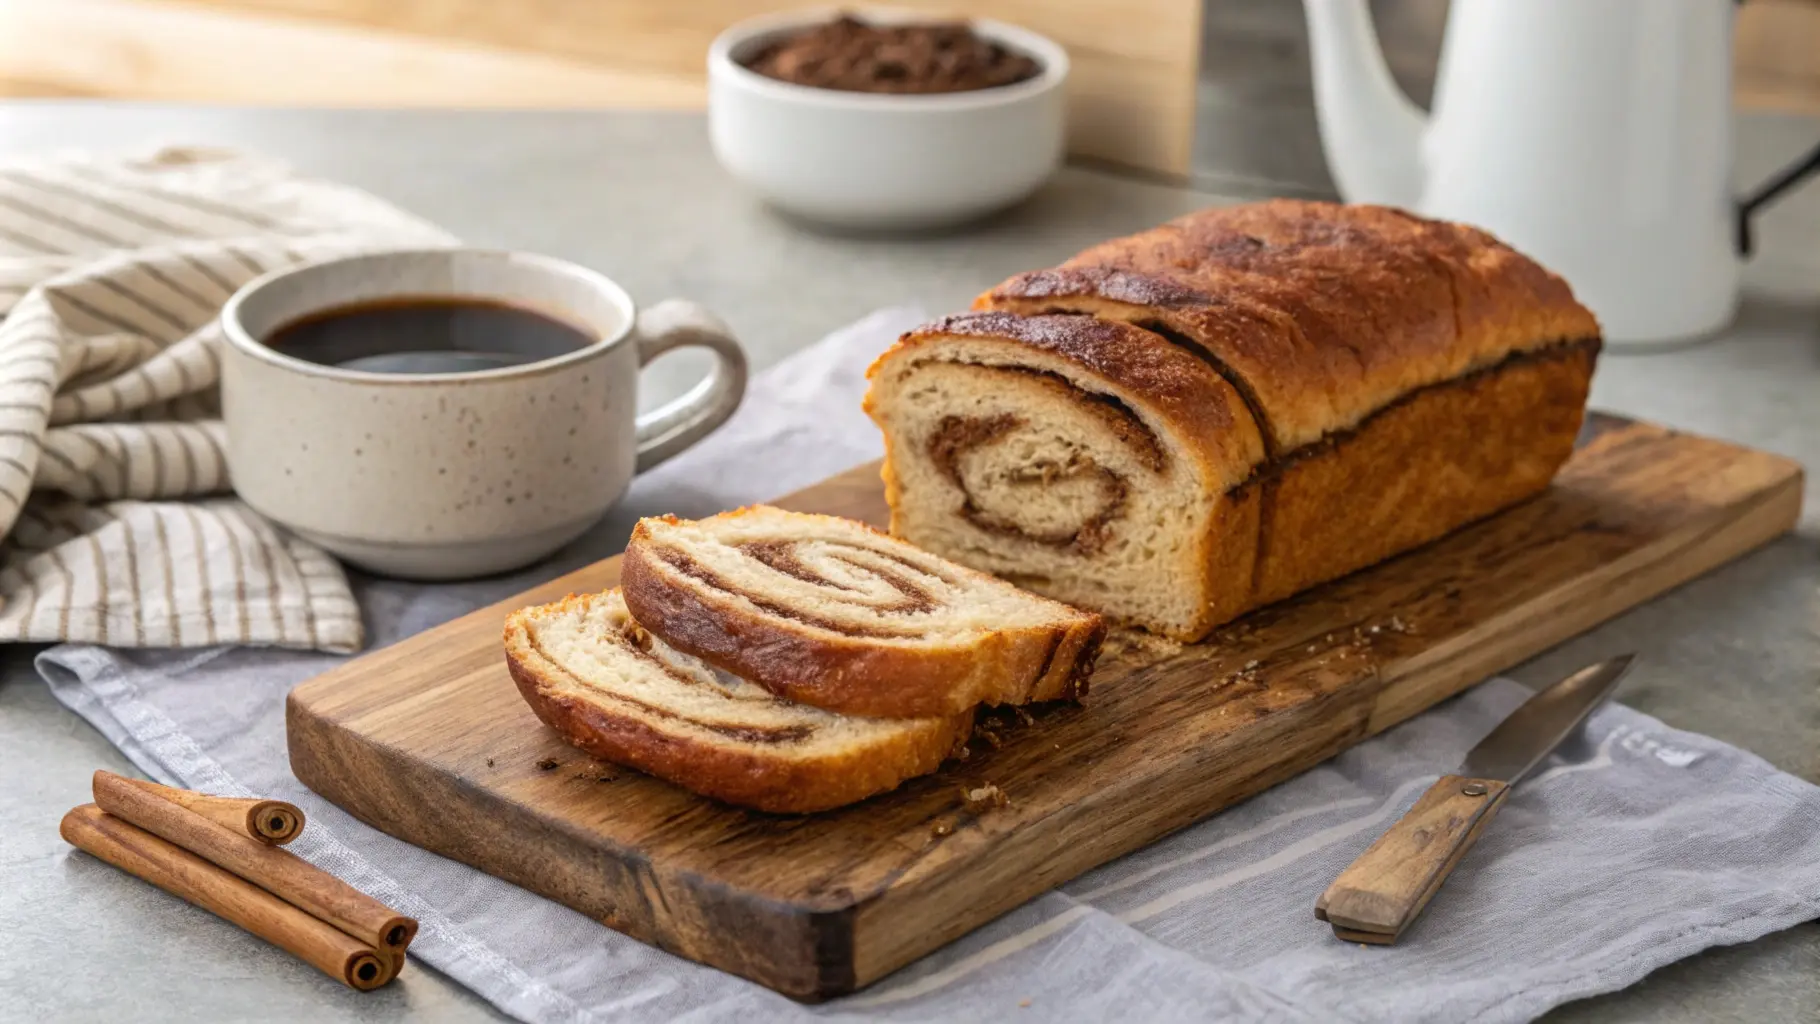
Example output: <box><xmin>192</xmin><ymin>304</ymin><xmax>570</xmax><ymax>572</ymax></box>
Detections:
<box><xmin>1314</xmin><ymin>655</ymin><xmax>1634</xmax><ymax>946</ymax></box>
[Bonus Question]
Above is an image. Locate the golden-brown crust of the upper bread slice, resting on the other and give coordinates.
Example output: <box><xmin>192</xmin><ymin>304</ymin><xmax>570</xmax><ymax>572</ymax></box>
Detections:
<box><xmin>619</xmin><ymin>509</ymin><xmax>1107</xmax><ymax>718</ymax></box>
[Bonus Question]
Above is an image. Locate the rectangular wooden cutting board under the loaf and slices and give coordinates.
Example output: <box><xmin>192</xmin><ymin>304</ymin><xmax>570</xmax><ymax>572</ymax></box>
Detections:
<box><xmin>288</xmin><ymin>418</ymin><xmax>1802</xmax><ymax>1000</ymax></box>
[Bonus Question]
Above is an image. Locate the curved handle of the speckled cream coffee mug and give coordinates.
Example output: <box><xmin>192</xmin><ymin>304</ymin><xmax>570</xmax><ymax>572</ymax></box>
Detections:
<box><xmin>633</xmin><ymin>298</ymin><xmax>746</xmax><ymax>473</ymax></box>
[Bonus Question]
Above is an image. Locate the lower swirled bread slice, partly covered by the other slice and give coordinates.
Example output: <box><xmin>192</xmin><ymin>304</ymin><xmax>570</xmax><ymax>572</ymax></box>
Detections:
<box><xmin>506</xmin><ymin>589</ymin><xmax>974</xmax><ymax>813</ymax></box>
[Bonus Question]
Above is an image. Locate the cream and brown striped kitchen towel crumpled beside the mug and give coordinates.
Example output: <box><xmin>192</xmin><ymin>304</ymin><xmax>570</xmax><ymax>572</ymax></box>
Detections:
<box><xmin>0</xmin><ymin>149</ymin><xmax>453</xmax><ymax>651</ymax></box>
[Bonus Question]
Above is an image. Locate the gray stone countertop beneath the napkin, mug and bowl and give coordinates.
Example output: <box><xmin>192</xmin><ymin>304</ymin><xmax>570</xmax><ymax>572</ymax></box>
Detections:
<box><xmin>0</xmin><ymin>104</ymin><xmax>1820</xmax><ymax>1024</ymax></box>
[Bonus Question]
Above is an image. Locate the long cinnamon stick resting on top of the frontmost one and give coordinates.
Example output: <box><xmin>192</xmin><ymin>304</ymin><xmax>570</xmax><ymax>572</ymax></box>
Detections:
<box><xmin>95</xmin><ymin>771</ymin><xmax>417</xmax><ymax>951</ymax></box>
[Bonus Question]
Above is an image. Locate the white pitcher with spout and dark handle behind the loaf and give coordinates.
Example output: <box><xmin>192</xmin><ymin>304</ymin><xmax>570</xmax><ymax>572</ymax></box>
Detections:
<box><xmin>1303</xmin><ymin>0</ymin><xmax>1820</xmax><ymax>344</ymax></box>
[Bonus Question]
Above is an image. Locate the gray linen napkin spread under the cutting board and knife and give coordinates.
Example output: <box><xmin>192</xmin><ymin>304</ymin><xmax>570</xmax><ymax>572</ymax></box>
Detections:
<box><xmin>40</xmin><ymin>309</ymin><xmax>1820</xmax><ymax>1022</ymax></box>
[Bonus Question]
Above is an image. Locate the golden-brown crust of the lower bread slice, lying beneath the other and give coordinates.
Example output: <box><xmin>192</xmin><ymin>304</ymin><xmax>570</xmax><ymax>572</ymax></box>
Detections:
<box><xmin>504</xmin><ymin>595</ymin><xmax>974</xmax><ymax>813</ymax></box>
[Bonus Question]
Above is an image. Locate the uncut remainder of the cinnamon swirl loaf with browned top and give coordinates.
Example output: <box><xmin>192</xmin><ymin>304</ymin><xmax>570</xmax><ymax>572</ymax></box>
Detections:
<box><xmin>866</xmin><ymin>200</ymin><xmax>1600</xmax><ymax>640</ymax></box>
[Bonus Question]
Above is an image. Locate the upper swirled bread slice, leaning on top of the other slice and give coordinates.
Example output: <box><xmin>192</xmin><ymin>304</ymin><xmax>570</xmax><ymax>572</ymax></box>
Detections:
<box><xmin>621</xmin><ymin>506</ymin><xmax>1105</xmax><ymax>718</ymax></box>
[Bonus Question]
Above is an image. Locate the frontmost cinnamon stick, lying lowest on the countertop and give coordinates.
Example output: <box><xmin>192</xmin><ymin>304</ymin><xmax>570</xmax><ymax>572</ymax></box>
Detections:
<box><xmin>58</xmin><ymin>804</ymin><xmax>393</xmax><ymax>991</ymax></box>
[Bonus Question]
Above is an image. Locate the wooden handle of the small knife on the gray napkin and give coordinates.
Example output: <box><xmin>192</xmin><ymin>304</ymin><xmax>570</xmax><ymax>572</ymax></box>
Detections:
<box><xmin>1314</xmin><ymin>775</ymin><xmax>1511</xmax><ymax>946</ymax></box>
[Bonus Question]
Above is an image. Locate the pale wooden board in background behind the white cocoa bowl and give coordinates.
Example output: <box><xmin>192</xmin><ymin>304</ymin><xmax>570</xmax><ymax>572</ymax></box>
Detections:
<box><xmin>0</xmin><ymin>0</ymin><xmax>1201</xmax><ymax>175</ymax></box>
